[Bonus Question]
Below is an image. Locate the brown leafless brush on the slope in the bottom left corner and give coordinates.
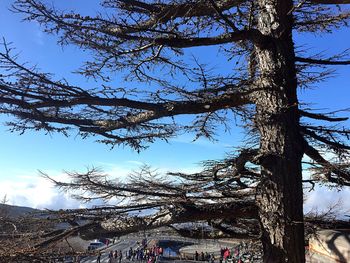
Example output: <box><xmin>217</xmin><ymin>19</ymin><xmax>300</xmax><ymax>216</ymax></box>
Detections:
<box><xmin>0</xmin><ymin>201</ymin><xmax>73</xmax><ymax>262</ymax></box>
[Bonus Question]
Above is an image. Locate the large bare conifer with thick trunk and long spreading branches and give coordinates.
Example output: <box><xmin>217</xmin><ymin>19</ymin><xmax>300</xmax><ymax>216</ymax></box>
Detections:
<box><xmin>0</xmin><ymin>0</ymin><xmax>350</xmax><ymax>263</ymax></box>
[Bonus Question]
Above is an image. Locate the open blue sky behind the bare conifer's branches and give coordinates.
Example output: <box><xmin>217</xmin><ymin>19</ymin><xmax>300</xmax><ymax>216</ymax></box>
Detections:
<box><xmin>0</xmin><ymin>0</ymin><xmax>350</xmax><ymax>214</ymax></box>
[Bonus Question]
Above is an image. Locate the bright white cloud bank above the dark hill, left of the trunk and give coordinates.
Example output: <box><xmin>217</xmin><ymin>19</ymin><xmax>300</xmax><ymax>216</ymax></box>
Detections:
<box><xmin>0</xmin><ymin>160</ymin><xmax>199</xmax><ymax>209</ymax></box>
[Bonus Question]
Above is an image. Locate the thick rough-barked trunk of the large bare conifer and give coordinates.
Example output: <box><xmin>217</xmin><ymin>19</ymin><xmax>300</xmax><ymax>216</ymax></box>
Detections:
<box><xmin>255</xmin><ymin>0</ymin><xmax>305</xmax><ymax>263</ymax></box>
